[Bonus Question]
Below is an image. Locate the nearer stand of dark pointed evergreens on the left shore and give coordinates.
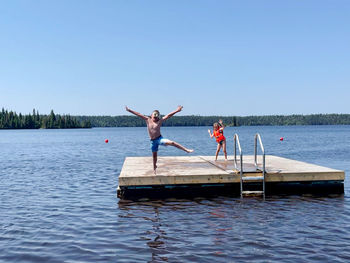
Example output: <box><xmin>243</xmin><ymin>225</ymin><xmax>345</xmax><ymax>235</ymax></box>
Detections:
<box><xmin>0</xmin><ymin>108</ymin><xmax>91</xmax><ymax>129</ymax></box>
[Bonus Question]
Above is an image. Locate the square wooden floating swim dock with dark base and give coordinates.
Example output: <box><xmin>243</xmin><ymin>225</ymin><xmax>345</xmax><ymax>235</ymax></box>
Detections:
<box><xmin>117</xmin><ymin>155</ymin><xmax>345</xmax><ymax>199</ymax></box>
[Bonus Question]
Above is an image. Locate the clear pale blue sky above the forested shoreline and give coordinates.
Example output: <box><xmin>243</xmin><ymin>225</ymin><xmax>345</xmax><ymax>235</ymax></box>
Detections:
<box><xmin>0</xmin><ymin>0</ymin><xmax>350</xmax><ymax>116</ymax></box>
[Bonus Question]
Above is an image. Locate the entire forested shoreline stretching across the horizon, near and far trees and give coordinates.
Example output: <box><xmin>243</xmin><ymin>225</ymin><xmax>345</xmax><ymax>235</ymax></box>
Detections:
<box><xmin>0</xmin><ymin>108</ymin><xmax>350</xmax><ymax>129</ymax></box>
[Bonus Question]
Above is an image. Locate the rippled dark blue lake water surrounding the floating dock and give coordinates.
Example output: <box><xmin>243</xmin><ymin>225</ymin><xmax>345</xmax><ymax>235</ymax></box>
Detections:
<box><xmin>0</xmin><ymin>126</ymin><xmax>350</xmax><ymax>263</ymax></box>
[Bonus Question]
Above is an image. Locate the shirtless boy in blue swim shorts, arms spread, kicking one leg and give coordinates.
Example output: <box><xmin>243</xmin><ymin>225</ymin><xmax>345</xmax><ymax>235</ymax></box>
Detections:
<box><xmin>125</xmin><ymin>106</ymin><xmax>193</xmax><ymax>174</ymax></box>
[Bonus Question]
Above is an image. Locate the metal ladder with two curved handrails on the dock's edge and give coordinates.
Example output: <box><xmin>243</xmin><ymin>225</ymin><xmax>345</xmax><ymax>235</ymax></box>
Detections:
<box><xmin>233</xmin><ymin>133</ymin><xmax>266</xmax><ymax>198</ymax></box>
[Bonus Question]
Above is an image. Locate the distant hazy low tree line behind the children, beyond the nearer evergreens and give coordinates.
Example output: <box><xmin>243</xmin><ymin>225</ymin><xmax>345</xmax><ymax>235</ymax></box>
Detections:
<box><xmin>76</xmin><ymin>114</ymin><xmax>350</xmax><ymax>127</ymax></box>
